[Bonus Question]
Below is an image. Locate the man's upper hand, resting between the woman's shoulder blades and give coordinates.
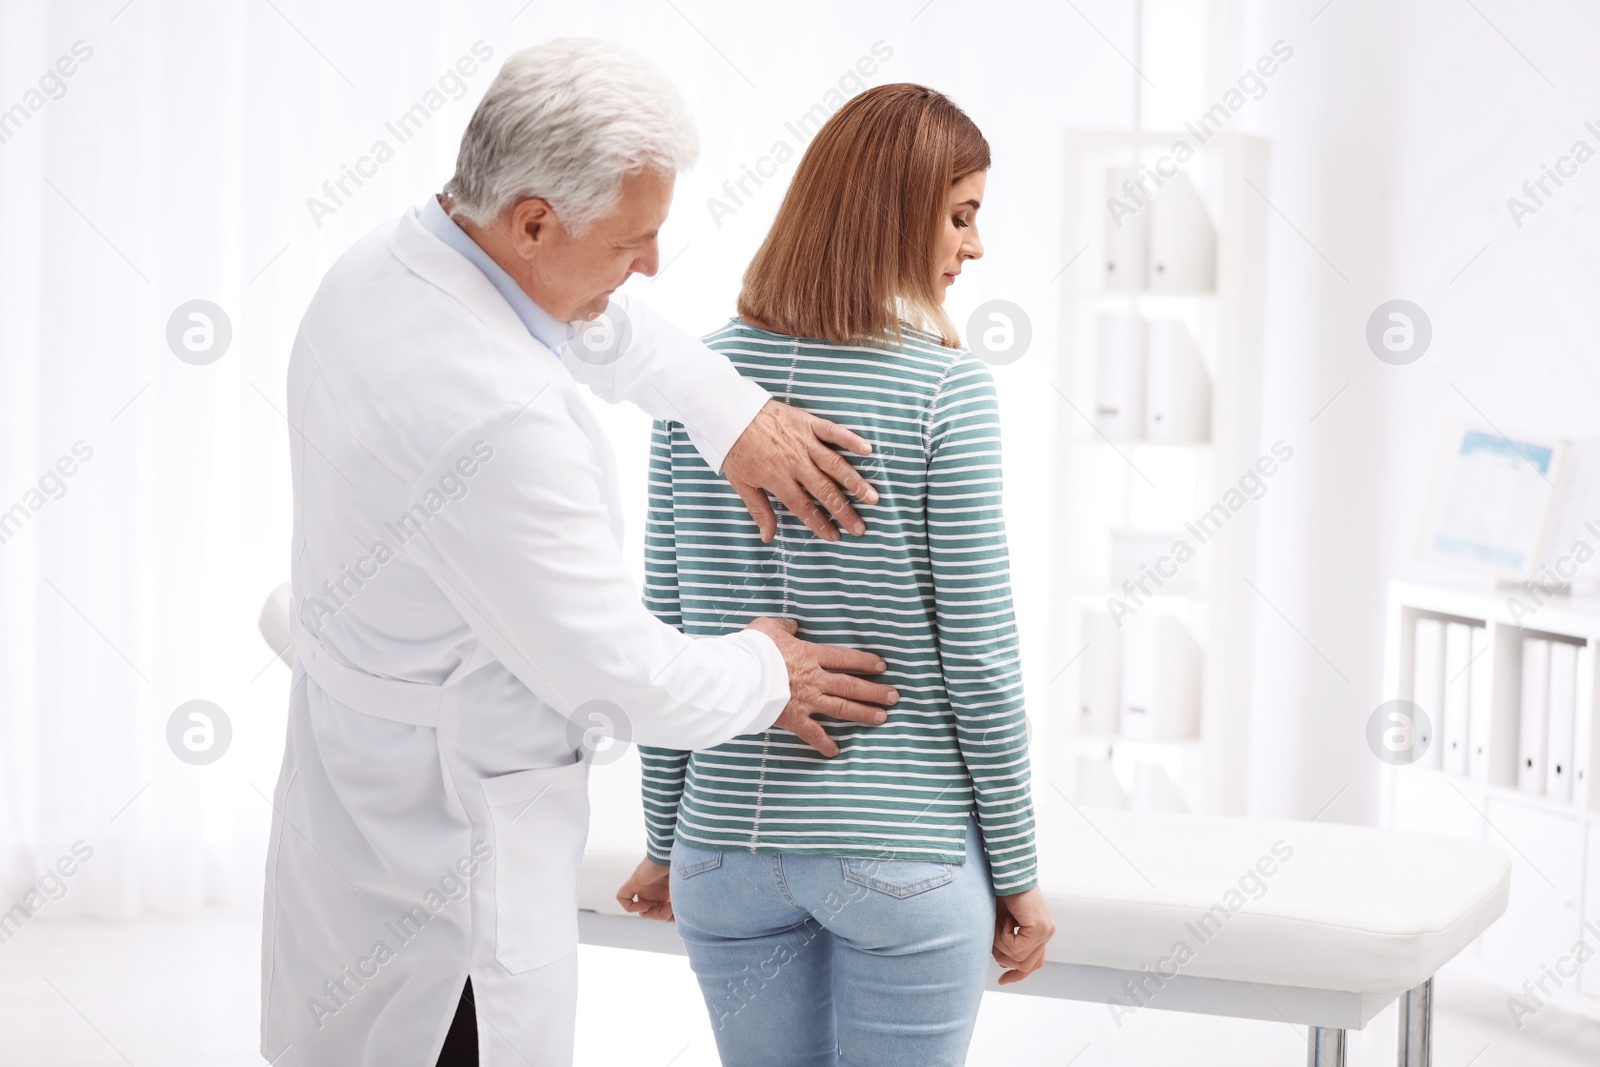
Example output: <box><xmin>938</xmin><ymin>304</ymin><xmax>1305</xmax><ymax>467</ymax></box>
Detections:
<box><xmin>722</xmin><ymin>400</ymin><xmax>878</xmax><ymax>542</ymax></box>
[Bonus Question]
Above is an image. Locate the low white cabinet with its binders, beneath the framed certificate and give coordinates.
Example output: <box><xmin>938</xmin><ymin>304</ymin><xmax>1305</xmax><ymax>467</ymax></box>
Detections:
<box><xmin>1374</xmin><ymin>584</ymin><xmax>1600</xmax><ymax>1019</ymax></box>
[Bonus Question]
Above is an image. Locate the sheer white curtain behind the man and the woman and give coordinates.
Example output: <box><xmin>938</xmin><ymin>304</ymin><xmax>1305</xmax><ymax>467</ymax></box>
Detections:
<box><xmin>0</xmin><ymin>0</ymin><xmax>1133</xmax><ymax>918</ymax></box>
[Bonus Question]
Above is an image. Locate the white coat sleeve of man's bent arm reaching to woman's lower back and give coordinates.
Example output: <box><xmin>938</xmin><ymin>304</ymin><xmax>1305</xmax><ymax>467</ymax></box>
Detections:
<box><xmin>408</xmin><ymin>384</ymin><xmax>789</xmax><ymax>749</ymax></box>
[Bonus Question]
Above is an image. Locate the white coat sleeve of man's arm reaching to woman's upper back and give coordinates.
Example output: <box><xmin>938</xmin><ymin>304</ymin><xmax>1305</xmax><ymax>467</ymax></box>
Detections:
<box><xmin>557</xmin><ymin>294</ymin><xmax>771</xmax><ymax>474</ymax></box>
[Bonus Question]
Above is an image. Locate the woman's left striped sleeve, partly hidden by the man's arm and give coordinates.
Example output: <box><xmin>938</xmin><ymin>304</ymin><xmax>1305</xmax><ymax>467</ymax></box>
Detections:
<box><xmin>638</xmin><ymin>421</ymin><xmax>690</xmax><ymax>867</ymax></box>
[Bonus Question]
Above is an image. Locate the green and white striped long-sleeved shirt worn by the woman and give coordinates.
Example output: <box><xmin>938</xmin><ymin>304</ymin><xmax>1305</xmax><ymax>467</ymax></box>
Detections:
<box><xmin>640</xmin><ymin>318</ymin><xmax>1037</xmax><ymax>894</ymax></box>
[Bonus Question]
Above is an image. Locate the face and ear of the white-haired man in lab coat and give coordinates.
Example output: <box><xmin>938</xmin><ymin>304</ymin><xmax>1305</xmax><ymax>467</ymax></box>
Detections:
<box><xmin>509</xmin><ymin>170</ymin><xmax>675</xmax><ymax>322</ymax></box>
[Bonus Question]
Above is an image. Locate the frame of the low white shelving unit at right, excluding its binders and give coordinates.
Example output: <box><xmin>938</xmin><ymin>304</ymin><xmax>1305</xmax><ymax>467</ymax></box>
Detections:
<box><xmin>1381</xmin><ymin>584</ymin><xmax>1600</xmax><ymax>1019</ymax></box>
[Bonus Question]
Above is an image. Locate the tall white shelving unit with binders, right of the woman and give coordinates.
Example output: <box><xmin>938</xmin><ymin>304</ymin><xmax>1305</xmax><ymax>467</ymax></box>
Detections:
<box><xmin>1048</xmin><ymin>130</ymin><xmax>1267</xmax><ymax>814</ymax></box>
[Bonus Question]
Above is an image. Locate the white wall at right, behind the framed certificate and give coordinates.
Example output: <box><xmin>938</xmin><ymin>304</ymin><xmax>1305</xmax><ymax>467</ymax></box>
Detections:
<box><xmin>1221</xmin><ymin>0</ymin><xmax>1600</xmax><ymax>821</ymax></box>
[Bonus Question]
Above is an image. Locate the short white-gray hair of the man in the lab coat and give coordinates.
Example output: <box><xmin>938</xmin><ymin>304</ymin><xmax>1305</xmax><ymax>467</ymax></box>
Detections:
<box><xmin>445</xmin><ymin>37</ymin><xmax>699</xmax><ymax>234</ymax></box>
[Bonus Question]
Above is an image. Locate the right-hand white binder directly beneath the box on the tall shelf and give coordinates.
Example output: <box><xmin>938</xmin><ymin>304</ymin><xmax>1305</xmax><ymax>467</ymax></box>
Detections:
<box><xmin>1122</xmin><ymin>611</ymin><xmax>1200</xmax><ymax>741</ymax></box>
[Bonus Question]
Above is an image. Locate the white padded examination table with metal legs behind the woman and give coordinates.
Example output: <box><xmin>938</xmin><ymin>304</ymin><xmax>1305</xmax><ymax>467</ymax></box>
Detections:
<box><xmin>579</xmin><ymin>812</ymin><xmax>1510</xmax><ymax>1067</ymax></box>
